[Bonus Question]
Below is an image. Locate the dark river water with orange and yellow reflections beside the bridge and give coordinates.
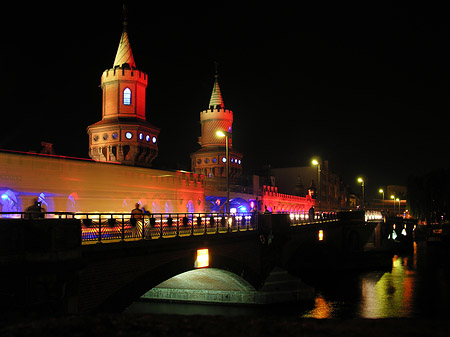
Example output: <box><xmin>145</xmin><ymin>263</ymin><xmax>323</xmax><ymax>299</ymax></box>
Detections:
<box><xmin>127</xmin><ymin>242</ymin><xmax>450</xmax><ymax>318</ymax></box>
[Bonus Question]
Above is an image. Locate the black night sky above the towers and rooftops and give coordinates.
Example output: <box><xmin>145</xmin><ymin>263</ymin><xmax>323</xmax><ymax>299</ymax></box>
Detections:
<box><xmin>0</xmin><ymin>1</ymin><xmax>450</xmax><ymax>200</ymax></box>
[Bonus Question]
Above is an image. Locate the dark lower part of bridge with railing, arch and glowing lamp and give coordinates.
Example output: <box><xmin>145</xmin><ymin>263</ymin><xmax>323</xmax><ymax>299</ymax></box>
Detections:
<box><xmin>0</xmin><ymin>212</ymin><xmax>390</xmax><ymax>313</ymax></box>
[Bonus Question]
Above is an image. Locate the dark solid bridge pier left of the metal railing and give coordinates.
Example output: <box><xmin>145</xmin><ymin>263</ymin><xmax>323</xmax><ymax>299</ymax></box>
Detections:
<box><xmin>0</xmin><ymin>219</ymin><xmax>82</xmax><ymax>314</ymax></box>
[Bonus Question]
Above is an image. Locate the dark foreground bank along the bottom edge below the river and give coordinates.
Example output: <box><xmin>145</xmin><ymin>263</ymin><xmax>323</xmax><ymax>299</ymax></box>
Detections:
<box><xmin>0</xmin><ymin>314</ymin><xmax>450</xmax><ymax>337</ymax></box>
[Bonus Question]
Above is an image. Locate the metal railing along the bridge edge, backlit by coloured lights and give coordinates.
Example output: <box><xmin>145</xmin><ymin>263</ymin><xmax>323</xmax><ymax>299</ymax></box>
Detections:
<box><xmin>0</xmin><ymin>211</ymin><xmax>339</xmax><ymax>244</ymax></box>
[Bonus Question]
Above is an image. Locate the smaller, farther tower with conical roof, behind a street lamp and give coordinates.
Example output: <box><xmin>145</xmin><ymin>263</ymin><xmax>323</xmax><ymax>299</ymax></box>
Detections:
<box><xmin>191</xmin><ymin>70</ymin><xmax>242</xmax><ymax>179</ymax></box>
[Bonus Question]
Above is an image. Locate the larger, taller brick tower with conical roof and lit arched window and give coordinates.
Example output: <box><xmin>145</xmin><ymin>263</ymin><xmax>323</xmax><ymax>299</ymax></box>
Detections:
<box><xmin>87</xmin><ymin>11</ymin><xmax>159</xmax><ymax>167</ymax></box>
